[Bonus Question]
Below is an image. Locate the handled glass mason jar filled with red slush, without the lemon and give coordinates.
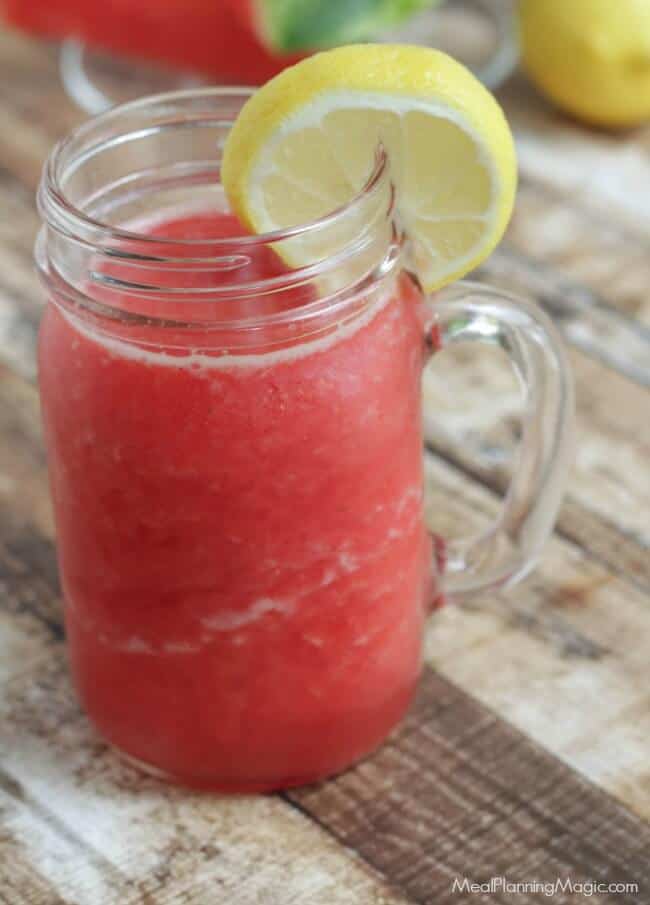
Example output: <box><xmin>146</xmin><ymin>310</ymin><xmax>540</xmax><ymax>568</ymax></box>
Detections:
<box><xmin>37</xmin><ymin>74</ymin><xmax>567</xmax><ymax>791</ymax></box>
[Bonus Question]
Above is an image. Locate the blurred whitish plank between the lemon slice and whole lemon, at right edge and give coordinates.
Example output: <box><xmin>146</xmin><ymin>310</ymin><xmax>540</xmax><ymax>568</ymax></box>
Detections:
<box><xmin>486</xmin><ymin>75</ymin><xmax>650</xmax><ymax>376</ymax></box>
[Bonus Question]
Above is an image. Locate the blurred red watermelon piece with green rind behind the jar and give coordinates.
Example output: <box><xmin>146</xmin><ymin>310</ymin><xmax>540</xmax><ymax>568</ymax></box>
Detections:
<box><xmin>0</xmin><ymin>0</ymin><xmax>436</xmax><ymax>85</ymax></box>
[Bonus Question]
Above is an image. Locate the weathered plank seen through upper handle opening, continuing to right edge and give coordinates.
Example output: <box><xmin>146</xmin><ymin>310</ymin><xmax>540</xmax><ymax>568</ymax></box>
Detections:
<box><xmin>423</xmin><ymin>346</ymin><xmax>650</xmax><ymax>587</ymax></box>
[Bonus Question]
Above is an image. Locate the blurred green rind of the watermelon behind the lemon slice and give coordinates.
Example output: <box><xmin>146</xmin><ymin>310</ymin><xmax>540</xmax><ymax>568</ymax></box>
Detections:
<box><xmin>256</xmin><ymin>0</ymin><xmax>436</xmax><ymax>53</ymax></box>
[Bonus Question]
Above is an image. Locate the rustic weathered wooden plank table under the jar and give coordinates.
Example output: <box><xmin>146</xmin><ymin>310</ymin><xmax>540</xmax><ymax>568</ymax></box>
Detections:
<box><xmin>0</xmin><ymin>21</ymin><xmax>650</xmax><ymax>905</ymax></box>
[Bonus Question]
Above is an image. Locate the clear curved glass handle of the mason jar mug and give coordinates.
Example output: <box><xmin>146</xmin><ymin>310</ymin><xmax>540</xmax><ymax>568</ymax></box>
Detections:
<box><xmin>425</xmin><ymin>283</ymin><xmax>574</xmax><ymax>600</ymax></box>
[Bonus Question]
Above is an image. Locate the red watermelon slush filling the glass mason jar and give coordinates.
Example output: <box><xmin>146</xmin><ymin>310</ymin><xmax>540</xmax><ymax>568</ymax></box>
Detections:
<box><xmin>40</xmin><ymin>213</ymin><xmax>431</xmax><ymax>789</ymax></box>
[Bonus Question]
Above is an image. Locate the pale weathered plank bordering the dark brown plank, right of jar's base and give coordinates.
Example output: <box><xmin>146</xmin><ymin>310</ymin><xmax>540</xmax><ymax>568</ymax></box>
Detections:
<box><xmin>418</xmin><ymin>457</ymin><xmax>650</xmax><ymax>819</ymax></box>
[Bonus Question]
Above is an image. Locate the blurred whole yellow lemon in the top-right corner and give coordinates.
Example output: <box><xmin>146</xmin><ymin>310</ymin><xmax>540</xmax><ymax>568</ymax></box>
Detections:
<box><xmin>519</xmin><ymin>0</ymin><xmax>650</xmax><ymax>126</ymax></box>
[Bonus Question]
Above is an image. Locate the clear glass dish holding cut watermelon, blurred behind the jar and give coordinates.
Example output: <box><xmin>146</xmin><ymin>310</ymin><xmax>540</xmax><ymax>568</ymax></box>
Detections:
<box><xmin>5</xmin><ymin>0</ymin><xmax>516</xmax><ymax>113</ymax></box>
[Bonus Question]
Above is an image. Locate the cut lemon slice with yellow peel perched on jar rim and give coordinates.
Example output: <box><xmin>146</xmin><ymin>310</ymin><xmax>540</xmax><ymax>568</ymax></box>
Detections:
<box><xmin>222</xmin><ymin>44</ymin><xmax>517</xmax><ymax>290</ymax></box>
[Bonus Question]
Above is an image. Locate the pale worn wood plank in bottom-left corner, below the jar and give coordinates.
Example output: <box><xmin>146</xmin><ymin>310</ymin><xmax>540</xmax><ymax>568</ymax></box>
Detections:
<box><xmin>0</xmin><ymin>656</ymin><xmax>407</xmax><ymax>905</ymax></box>
